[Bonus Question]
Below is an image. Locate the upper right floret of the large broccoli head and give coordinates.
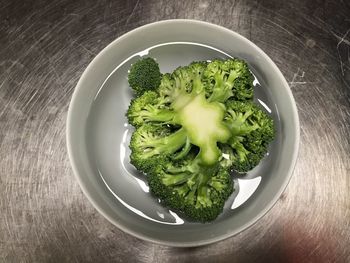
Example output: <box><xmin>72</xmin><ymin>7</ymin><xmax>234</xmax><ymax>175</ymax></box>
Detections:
<box><xmin>203</xmin><ymin>59</ymin><xmax>254</xmax><ymax>103</ymax></box>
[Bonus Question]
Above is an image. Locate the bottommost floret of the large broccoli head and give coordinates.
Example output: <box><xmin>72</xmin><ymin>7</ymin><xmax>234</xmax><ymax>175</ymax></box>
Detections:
<box><xmin>147</xmin><ymin>158</ymin><xmax>233</xmax><ymax>222</ymax></box>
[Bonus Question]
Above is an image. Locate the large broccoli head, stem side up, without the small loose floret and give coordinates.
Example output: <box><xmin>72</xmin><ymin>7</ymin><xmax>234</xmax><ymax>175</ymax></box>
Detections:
<box><xmin>126</xmin><ymin>59</ymin><xmax>274</xmax><ymax>222</ymax></box>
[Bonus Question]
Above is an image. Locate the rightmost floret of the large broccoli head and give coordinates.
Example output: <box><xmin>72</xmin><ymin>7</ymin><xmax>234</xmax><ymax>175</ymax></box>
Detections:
<box><xmin>221</xmin><ymin>101</ymin><xmax>274</xmax><ymax>173</ymax></box>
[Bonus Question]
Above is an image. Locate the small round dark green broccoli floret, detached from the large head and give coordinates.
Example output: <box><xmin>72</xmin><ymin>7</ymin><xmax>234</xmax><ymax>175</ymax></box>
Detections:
<box><xmin>128</xmin><ymin>57</ymin><xmax>162</xmax><ymax>96</ymax></box>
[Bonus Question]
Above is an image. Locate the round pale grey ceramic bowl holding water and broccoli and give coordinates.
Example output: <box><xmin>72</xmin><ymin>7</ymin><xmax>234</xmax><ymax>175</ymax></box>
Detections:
<box><xmin>67</xmin><ymin>20</ymin><xmax>299</xmax><ymax>246</ymax></box>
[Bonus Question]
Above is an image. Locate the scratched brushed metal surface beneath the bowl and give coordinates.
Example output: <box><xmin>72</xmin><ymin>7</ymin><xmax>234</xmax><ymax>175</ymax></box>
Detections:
<box><xmin>0</xmin><ymin>0</ymin><xmax>350</xmax><ymax>262</ymax></box>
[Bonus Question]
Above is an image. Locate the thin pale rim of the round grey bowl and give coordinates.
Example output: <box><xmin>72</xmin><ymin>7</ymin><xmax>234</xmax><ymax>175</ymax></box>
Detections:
<box><xmin>66</xmin><ymin>19</ymin><xmax>300</xmax><ymax>247</ymax></box>
